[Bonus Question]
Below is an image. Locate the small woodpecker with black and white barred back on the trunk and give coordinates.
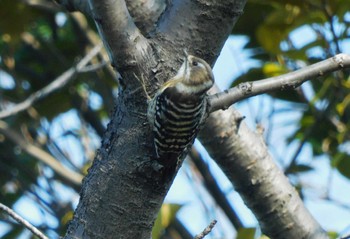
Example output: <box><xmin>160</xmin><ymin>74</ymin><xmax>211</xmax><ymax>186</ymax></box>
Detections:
<box><xmin>148</xmin><ymin>55</ymin><xmax>214</xmax><ymax>163</ymax></box>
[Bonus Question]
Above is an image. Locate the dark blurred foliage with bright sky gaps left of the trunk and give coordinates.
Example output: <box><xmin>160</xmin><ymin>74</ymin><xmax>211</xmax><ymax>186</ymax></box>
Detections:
<box><xmin>0</xmin><ymin>0</ymin><xmax>117</xmax><ymax>238</ymax></box>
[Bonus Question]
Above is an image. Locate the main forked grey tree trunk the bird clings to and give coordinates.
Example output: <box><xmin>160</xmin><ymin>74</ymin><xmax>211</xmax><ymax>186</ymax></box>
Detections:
<box><xmin>65</xmin><ymin>0</ymin><xmax>245</xmax><ymax>238</ymax></box>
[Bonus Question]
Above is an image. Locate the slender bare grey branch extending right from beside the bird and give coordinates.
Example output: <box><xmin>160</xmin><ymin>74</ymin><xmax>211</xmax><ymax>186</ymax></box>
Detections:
<box><xmin>209</xmin><ymin>54</ymin><xmax>350</xmax><ymax>112</ymax></box>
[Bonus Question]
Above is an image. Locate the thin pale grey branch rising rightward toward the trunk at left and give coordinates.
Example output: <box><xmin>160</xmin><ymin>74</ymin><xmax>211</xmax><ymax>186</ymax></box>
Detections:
<box><xmin>0</xmin><ymin>44</ymin><xmax>102</xmax><ymax>119</ymax></box>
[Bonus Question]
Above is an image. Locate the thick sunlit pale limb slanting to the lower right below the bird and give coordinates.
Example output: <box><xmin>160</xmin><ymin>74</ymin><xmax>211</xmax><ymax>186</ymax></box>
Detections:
<box><xmin>199</xmin><ymin>88</ymin><xmax>328</xmax><ymax>239</ymax></box>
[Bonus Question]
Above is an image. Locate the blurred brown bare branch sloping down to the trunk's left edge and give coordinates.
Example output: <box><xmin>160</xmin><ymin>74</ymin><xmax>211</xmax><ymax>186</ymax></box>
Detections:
<box><xmin>0</xmin><ymin>120</ymin><xmax>83</xmax><ymax>186</ymax></box>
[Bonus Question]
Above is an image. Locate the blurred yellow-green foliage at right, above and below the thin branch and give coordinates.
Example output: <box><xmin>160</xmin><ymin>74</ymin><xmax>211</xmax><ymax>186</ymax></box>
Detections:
<box><xmin>233</xmin><ymin>0</ymin><xmax>350</xmax><ymax>180</ymax></box>
